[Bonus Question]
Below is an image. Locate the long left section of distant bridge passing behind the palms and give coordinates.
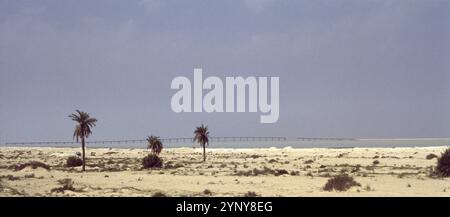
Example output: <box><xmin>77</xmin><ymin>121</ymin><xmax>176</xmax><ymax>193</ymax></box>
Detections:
<box><xmin>5</xmin><ymin>137</ymin><xmax>286</xmax><ymax>146</ymax></box>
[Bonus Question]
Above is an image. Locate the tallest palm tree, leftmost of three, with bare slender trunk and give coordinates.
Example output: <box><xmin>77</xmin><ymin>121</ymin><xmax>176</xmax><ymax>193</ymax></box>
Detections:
<box><xmin>69</xmin><ymin>110</ymin><xmax>97</xmax><ymax>171</ymax></box>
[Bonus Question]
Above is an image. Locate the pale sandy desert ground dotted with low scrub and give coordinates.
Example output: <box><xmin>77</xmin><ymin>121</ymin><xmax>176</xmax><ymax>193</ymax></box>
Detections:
<box><xmin>0</xmin><ymin>147</ymin><xmax>450</xmax><ymax>197</ymax></box>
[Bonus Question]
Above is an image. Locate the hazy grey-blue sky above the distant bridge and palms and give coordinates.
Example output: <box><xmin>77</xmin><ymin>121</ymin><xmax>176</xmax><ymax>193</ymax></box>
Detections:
<box><xmin>0</xmin><ymin>0</ymin><xmax>450</xmax><ymax>143</ymax></box>
